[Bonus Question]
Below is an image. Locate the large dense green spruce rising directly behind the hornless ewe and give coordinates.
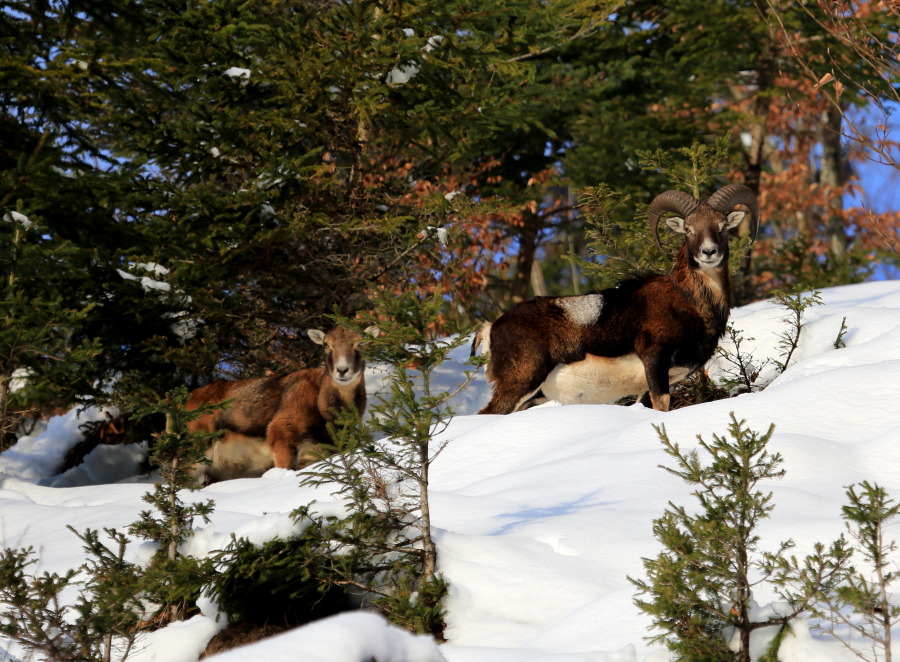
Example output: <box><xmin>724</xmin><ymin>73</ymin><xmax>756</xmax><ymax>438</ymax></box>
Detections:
<box><xmin>51</xmin><ymin>0</ymin><xmax>612</xmax><ymax>392</ymax></box>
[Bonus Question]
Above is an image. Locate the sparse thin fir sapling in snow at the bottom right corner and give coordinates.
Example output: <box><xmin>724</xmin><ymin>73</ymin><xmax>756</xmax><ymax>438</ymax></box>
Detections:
<box><xmin>813</xmin><ymin>481</ymin><xmax>900</xmax><ymax>662</ymax></box>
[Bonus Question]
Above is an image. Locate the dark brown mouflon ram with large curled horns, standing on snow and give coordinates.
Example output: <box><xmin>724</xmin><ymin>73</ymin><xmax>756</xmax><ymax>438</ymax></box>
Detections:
<box><xmin>472</xmin><ymin>184</ymin><xmax>759</xmax><ymax>414</ymax></box>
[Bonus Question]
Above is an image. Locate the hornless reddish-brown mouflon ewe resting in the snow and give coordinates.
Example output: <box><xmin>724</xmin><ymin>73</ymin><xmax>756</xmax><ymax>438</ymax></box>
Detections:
<box><xmin>187</xmin><ymin>327</ymin><xmax>375</xmax><ymax>482</ymax></box>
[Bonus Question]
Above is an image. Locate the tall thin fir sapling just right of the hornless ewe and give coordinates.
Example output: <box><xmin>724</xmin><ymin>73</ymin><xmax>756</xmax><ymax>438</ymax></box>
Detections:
<box><xmin>297</xmin><ymin>292</ymin><xmax>474</xmax><ymax>635</ymax></box>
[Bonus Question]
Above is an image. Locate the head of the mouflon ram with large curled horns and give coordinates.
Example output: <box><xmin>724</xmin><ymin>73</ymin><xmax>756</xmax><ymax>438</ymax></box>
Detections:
<box><xmin>647</xmin><ymin>184</ymin><xmax>759</xmax><ymax>267</ymax></box>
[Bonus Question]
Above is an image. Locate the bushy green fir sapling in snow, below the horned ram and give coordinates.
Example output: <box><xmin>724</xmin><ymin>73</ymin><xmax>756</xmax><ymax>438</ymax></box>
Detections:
<box><xmin>629</xmin><ymin>413</ymin><xmax>849</xmax><ymax>662</ymax></box>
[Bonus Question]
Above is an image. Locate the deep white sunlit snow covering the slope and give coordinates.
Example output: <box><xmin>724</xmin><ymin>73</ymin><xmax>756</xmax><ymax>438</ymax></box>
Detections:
<box><xmin>0</xmin><ymin>282</ymin><xmax>900</xmax><ymax>662</ymax></box>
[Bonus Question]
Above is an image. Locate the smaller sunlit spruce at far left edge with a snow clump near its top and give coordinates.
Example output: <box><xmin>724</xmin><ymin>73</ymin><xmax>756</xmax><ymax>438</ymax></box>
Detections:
<box><xmin>0</xmin><ymin>144</ymin><xmax>100</xmax><ymax>449</ymax></box>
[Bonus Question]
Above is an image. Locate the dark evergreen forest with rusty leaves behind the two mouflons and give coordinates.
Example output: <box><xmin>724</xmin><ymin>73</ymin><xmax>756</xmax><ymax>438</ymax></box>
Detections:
<box><xmin>0</xmin><ymin>0</ymin><xmax>900</xmax><ymax>432</ymax></box>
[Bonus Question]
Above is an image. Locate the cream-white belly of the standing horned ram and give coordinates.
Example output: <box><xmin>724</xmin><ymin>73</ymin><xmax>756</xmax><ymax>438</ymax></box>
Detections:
<box><xmin>541</xmin><ymin>354</ymin><xmax>691</xmax><ymax>405</ymax></box>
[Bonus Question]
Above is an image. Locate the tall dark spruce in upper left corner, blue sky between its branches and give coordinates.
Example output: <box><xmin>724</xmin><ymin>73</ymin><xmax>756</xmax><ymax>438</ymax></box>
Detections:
<box><xmin>0</xmin><ymin>0</ymin><xmax>183</xmax><ymax>416</ymax></box>
